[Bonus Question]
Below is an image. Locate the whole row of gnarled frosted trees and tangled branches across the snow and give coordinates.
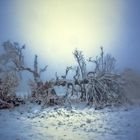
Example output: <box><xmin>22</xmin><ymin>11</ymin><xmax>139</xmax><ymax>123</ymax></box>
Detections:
<box><xmin>0</xmin><ymin>41</ymin><xmax>126</xmax><ymax>108</ymax></box>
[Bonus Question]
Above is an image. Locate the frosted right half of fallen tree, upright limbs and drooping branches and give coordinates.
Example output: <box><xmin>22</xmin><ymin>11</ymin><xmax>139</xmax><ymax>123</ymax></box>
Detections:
<box><xmin>64</xmin><ymin>47</ymin><xmax>126</xmax><ymax>106</ymax></box>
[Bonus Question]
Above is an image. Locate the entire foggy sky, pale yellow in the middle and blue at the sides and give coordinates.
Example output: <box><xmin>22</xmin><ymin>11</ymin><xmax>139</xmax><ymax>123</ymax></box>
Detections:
<box><xmin>0</xmin><ymin>0</ymin><xmax>140</xmax><ymax>80</ymax></box>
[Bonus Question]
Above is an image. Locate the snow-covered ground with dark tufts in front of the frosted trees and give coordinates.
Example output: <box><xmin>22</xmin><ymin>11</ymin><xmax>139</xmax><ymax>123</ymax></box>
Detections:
<box><xmin>0</xmin><ymin>104</ymin><xmax>140</xmax><ymax>140</ymax></box>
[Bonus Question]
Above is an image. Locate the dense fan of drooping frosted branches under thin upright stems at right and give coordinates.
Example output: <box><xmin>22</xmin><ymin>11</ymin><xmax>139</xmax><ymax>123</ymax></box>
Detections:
<box><xmin>87</xmin><ymin>47</ymin><xmax>125</xmax><ymax>105</ymax></box>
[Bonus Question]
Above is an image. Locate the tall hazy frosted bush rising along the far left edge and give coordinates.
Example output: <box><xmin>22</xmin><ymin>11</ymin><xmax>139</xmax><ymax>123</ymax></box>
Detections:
<box><xmin>0</xmin><ymin>41</ymin><xmax>23</xmax><ymax>108</ymax></box>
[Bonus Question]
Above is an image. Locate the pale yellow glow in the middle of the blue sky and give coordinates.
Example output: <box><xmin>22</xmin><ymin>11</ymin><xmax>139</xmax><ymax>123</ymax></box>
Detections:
<box><xmin>16</xmin><ymin>0</ymin><xmax>123</xmax><ymax>71</ymax></box>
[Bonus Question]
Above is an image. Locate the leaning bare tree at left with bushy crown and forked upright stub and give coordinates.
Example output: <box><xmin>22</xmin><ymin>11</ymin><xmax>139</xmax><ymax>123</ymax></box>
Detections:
<box><xmin>3</xmin><ymin>41</ymin><xmax>47</xmax><ymax>82</ymax></box>
